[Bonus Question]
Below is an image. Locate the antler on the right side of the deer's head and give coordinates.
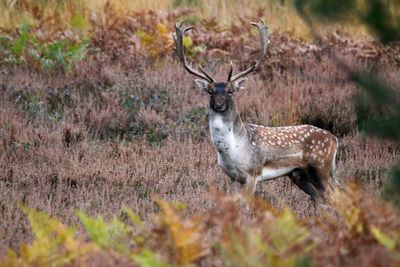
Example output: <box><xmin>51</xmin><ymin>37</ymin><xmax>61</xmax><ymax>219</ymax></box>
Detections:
<box><xmin>228</xmin><ymin>19</ymin><xmax>269</xmax><ymax>82</ymax></box>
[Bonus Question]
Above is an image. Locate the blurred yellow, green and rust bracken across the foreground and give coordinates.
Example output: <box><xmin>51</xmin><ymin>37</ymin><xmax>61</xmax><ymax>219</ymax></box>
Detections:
<box><xmin>0</xmin><ymin>188</ymin><xmax>400</xmax><ymax>267</ymax></box>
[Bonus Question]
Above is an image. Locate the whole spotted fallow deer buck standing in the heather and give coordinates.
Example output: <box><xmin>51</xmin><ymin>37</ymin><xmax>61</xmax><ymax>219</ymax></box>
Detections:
<box><xmin>173</xmin><ymin>20</ymin><xmax>338</xmax><ymax>201</ymax></box>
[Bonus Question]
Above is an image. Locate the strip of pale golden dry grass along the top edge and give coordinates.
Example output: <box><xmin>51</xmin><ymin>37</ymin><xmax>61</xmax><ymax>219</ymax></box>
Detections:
<box><xmin>0</xmin><ymin>0</ymin><xmax>368</xmax><ymax>39</ymax></box>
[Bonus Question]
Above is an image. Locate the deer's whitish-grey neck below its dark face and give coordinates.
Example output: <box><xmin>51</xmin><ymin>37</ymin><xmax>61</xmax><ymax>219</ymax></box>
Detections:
<box><xmin>209</xmin><ymin>103</ymin><xmax>248</xmax><ymax>154</ymax></box>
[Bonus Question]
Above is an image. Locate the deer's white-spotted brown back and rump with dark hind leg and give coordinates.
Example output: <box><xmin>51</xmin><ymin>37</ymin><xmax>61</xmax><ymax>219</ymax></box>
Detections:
<box><xmin>250</xmin><ymin>125</ymin><xmax>337</xmax><ymax>199</ymax></box>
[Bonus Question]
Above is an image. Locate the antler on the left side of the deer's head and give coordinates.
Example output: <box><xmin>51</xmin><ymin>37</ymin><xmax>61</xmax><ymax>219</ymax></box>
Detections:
<box><xmin>172</xmin><ymin>21</ymin><xmax>215</xmax><ymax>83</ymax></box>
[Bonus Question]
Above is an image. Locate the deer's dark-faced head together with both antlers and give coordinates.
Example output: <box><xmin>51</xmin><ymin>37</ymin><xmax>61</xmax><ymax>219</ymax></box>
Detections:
<box><xmin>173</xmin><ymin>20</ymin><xmax>268</xmax><ymax>112</ymax></box>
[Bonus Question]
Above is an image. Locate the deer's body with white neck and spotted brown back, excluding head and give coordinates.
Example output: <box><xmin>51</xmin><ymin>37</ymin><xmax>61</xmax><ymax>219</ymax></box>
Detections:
<box><xmin>210</xmin><ymin>103</ymin><xmax>338</xmax><ymax>200</ymax></box>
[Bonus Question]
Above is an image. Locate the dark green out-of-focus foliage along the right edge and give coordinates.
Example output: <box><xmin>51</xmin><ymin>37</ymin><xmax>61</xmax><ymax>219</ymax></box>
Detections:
<box><xmin>295</xmin><ymin>0</ymin><xmax>400</xmax><ymax>205</ymax></box>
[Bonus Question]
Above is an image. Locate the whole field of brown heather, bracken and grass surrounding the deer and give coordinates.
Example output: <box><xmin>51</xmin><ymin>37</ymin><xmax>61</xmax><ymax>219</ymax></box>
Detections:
<box><xmin>0</xmin><ymin>1</ymin><xmax>400</xmax><ymax>266</ymax></box>
